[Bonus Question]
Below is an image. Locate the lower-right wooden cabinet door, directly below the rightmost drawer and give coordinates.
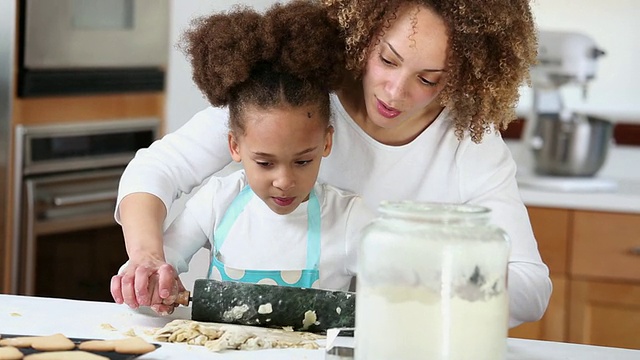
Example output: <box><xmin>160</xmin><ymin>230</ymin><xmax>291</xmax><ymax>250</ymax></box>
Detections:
<box><xmin>569</xmin><ymin>279</ymin><xmax>640</xmax><ymax>349</ymax></box>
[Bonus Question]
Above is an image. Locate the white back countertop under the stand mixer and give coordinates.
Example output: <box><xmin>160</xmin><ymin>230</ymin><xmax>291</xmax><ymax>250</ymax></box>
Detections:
<box><xmin>507</xmin><ymin>141</ymin><xmax>640</xmax><ymax>214</ymax></box>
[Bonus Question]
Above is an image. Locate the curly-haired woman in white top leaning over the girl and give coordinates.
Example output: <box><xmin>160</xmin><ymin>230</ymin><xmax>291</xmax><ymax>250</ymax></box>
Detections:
<box><xmin>110</xmin><ymin>0</ymin><xmax>551</xmax><ymax>326</ymax></box>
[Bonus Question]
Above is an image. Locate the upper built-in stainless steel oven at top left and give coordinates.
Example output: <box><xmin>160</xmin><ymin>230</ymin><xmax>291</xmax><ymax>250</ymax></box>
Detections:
<box><xmin>18</xmin><ymin>0</ymin><xmax>170</xmax><ymax>97</ymax></box>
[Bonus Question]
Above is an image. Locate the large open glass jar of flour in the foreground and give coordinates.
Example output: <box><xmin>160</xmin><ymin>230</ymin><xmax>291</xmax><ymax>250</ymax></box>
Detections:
<box><xmin>355</xmin><ymin>201</ymin><xmax>510</xmax><ymax>360</ymax></box>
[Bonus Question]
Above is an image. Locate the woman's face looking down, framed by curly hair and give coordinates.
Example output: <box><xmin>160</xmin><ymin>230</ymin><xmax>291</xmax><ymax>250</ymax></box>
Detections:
<box><xmin>363</xmin><ymin>5</ymin><xmax>448</xmax><ymax>129</ymax></box>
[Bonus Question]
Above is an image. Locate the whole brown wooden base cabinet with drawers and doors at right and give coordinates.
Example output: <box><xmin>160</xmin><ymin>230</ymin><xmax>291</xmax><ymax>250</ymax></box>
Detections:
<box><xmin>509</xmin><ymin>207</ymin><xmax>640</xmax><ymax>349</ymax></box>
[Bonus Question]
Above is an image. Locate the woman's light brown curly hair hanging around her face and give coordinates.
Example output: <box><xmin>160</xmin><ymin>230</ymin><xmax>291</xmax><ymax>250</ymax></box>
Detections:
<box><xmin>322</xmin><ymin>0</ymin><xmax>537</xmax><ymax>142</ymax></box>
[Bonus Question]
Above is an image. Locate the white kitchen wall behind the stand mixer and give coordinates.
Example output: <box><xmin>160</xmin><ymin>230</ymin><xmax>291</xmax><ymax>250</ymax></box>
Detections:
<box><xmin>519</xmin><ymin>0</ymin><xmax>640</xmax><ymax>122</ymax></box>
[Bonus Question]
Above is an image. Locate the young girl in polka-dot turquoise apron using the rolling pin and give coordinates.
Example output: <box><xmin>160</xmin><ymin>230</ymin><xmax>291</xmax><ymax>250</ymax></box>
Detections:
<box><xmin>112</xmin><ymin>2</ymin><xmax>373</xmax><ymax>311</ymax></box>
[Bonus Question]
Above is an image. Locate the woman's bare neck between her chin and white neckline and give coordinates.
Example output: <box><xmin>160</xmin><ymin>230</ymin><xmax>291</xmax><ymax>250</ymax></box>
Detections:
<box><xmin>336</xmin><ymin>81</ymin><xmax>444</xmax><ymax>146</ymax></box>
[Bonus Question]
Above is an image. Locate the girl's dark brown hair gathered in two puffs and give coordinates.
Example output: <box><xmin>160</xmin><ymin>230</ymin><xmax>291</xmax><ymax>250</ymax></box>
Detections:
<box><xmin>179</xmin><ymin>0</ymin><xmax>345</xmax><ymax>134</ymax></box>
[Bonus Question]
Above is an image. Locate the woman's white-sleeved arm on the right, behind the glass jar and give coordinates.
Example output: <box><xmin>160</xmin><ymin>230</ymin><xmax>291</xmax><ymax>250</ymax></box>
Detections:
<box><xmin>460</xmin><ymin>134</ymin><xmax>552</xmax><ymax>327</ymax></box>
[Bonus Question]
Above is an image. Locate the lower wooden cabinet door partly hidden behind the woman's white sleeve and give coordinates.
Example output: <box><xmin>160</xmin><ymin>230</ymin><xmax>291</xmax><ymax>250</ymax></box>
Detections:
<box><xmin>509</xmin><ymin>276</ymin><xmax>569</xmax><ymax>341</ymax></box>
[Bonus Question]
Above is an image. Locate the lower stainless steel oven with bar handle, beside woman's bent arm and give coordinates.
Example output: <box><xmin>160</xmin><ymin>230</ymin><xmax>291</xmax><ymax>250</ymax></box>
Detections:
<box><xmin>13</xmin><ymin>119</ymin><xmax>159</xmax><ymax>300</ymax></box>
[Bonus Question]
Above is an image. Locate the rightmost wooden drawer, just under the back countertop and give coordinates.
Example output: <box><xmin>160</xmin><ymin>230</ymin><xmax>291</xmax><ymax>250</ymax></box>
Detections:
<box><xmin>571</xmin><ymin>211</ymin><xmax>640</xmax><ymax>282</ymax></box>
